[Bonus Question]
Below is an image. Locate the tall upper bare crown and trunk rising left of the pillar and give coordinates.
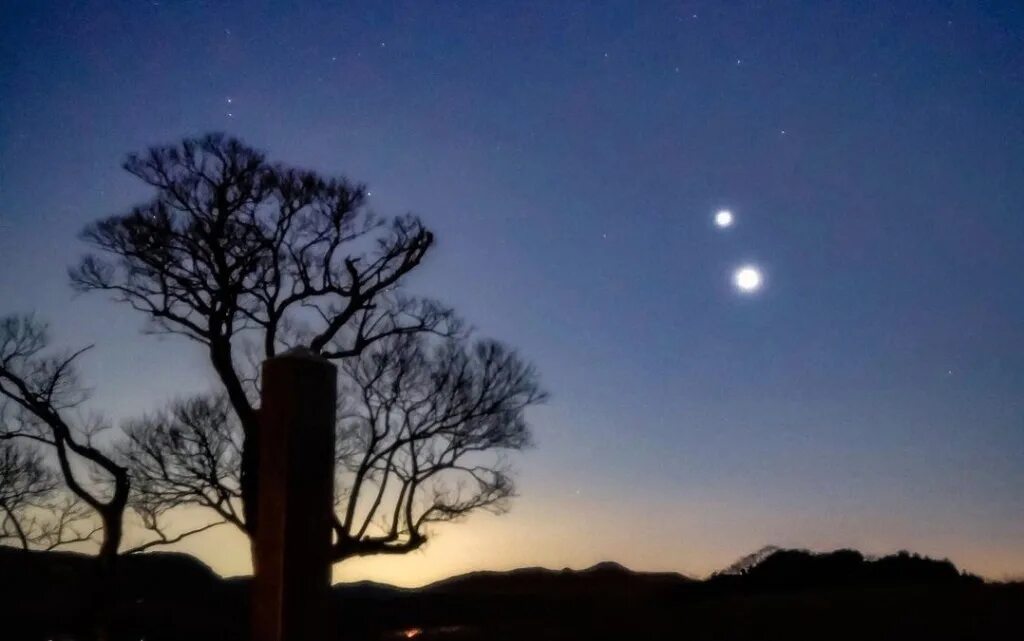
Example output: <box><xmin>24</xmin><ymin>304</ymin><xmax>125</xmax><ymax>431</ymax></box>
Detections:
<box><xmin>71</xmin><ymin>135</ymin><xmax>544</xmax><ymax>558</ymax></box>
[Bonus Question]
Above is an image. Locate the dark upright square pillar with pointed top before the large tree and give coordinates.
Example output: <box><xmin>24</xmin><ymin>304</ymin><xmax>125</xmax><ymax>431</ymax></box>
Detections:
<box><xmin>252</xmin><ymin>349</ymin><xmax>337</xmax><ymax>641</ymax></box>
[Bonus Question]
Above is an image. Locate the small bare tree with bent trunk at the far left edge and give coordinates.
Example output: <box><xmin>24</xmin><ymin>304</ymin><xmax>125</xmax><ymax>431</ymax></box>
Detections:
<box><xmin>0</xmin><ymin>315</ymin><xmax>223</xmax><ymax>557</ymax></box>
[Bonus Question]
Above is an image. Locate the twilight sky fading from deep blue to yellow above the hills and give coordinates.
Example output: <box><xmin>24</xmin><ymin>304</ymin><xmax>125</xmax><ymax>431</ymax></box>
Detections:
<box><xmin>0</xmin><ymin>0</ymin><xmax>1024</xmax><ymax>585</ymax></box>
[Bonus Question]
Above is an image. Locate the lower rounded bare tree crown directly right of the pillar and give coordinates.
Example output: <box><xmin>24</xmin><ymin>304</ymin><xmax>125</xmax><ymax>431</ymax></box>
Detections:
<box><xmin>335</xmin><ymin>329</ymin><xmax>545</xmax><ymax>558</ymax></box>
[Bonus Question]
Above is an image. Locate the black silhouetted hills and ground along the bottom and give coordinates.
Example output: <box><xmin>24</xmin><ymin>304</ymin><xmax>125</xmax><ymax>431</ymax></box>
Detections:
<box><xmin>0</xmin><ymin>548</ymin><xmax>1024</xmax><ymax>641</ymax></box>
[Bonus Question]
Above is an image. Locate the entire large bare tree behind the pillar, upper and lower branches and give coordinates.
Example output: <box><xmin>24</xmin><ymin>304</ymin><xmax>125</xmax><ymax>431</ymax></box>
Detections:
<box><xmin>71</xmin><ymin>135</ymin><xmax>541</xmax><ymax>560</ymax></box>
